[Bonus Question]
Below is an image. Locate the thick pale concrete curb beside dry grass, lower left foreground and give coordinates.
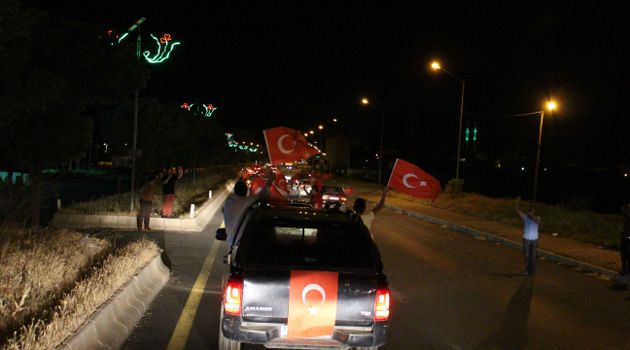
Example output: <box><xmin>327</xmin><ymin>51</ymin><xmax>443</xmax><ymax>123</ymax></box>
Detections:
<box><xmin>57</xmin><ymin>255</ymin><xmax>170</xmax><ymax>350</ymax></box>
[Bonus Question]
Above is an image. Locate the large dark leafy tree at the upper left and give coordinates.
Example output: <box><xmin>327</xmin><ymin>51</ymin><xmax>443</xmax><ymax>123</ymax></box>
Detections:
<box><xmin>0</xmin><ymin>0</ymin><xmax>146</xmax><ymax>227</ymax></box>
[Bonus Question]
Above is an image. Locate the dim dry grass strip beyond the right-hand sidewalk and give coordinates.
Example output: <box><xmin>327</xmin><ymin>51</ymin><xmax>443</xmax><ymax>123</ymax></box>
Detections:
<box><xmin>339</xmin><ymin>179</ymin><xmax>623</xmax><ymax>249</ymax></box>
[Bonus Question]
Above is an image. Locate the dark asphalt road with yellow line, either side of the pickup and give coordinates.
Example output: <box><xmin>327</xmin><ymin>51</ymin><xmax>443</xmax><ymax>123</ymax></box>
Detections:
<box><xmin>123</xmin><ymin>210</ymin><xmax>630</xmax><ymax>349</ymax></box>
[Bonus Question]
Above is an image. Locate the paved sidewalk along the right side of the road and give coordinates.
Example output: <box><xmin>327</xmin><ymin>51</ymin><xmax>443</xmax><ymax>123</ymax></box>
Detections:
<box><xmin>353</xmin><ymin>188</ymin><xmax>621</xmax><ymax>282</ymax></box>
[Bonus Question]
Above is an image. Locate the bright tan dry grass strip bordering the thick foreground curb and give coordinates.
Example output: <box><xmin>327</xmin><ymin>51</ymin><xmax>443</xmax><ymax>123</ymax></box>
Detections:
<box><xmin>2</xmin><ymin>239</ymin><xmax>160</xmax><ymax>350</ymax></box>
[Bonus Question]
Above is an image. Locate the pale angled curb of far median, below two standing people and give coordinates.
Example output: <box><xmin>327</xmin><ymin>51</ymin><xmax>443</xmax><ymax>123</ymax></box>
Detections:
<box><xmin>52</xmin><ymin>180</ymin><xmax>234</xmax><ymax>233</ymax></box>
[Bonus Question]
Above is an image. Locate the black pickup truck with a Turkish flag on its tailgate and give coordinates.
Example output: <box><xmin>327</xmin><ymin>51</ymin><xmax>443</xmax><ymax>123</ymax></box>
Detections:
<box><xmin>217</xmin><ymin>204</ymin><xmax>390</xmax><ymax>350</ymax></box>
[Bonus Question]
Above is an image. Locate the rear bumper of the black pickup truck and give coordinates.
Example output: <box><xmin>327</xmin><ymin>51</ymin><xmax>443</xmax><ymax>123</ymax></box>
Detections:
<box><xmin>221</xmin><ymin>315</ymin><xmax>389</xmax><ymax>349</ymax></box>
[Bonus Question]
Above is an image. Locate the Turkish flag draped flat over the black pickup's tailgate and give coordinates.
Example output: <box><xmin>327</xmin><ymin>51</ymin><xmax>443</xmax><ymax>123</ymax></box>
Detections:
<box><xmin>287</xmin><ymin>270</ymin><xmax>339</xmax><ymax>338</ymax></box>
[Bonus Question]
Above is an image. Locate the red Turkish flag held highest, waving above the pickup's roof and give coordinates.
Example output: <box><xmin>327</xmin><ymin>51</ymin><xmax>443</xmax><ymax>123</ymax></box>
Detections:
<box><xmin>263</xmin><ymin>127</ymin><xmax>319</xmax><ymax>164</ymax></box>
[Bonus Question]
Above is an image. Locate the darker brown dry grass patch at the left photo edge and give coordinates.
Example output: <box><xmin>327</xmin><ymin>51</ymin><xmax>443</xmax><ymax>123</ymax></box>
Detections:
<box><xmin>0</xmin><ymin>230</ymin><xmax>110</xmax><ymax>339</ymax></box>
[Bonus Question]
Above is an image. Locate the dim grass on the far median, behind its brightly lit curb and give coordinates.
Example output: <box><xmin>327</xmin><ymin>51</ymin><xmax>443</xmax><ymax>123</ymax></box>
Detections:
<box><xmin>60</xmin><ymin>170</ymin><xmax>235</xmax><ymax>216</ymax></box>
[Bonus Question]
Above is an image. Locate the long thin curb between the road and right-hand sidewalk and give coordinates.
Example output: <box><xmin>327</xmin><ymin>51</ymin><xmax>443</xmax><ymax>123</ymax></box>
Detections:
<box><xmin>385</xmin><ymin>204</ymin><xmax>628</xmax><ymax>284</ymax></box>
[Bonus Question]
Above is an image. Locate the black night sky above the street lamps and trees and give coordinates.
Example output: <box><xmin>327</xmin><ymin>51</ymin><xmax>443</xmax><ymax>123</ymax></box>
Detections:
<box><xmin>30</xmin><ymin>1</ymin><xmax>630</xmax><ymax>171</ymax></box>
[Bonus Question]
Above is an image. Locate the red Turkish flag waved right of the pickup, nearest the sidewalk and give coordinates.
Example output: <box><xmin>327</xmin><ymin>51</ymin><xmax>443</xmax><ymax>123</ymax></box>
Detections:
<box><xmin>387</xmin><ymin>159</ymin><xmax>442</xmax><ymax>201</ymax></box>
